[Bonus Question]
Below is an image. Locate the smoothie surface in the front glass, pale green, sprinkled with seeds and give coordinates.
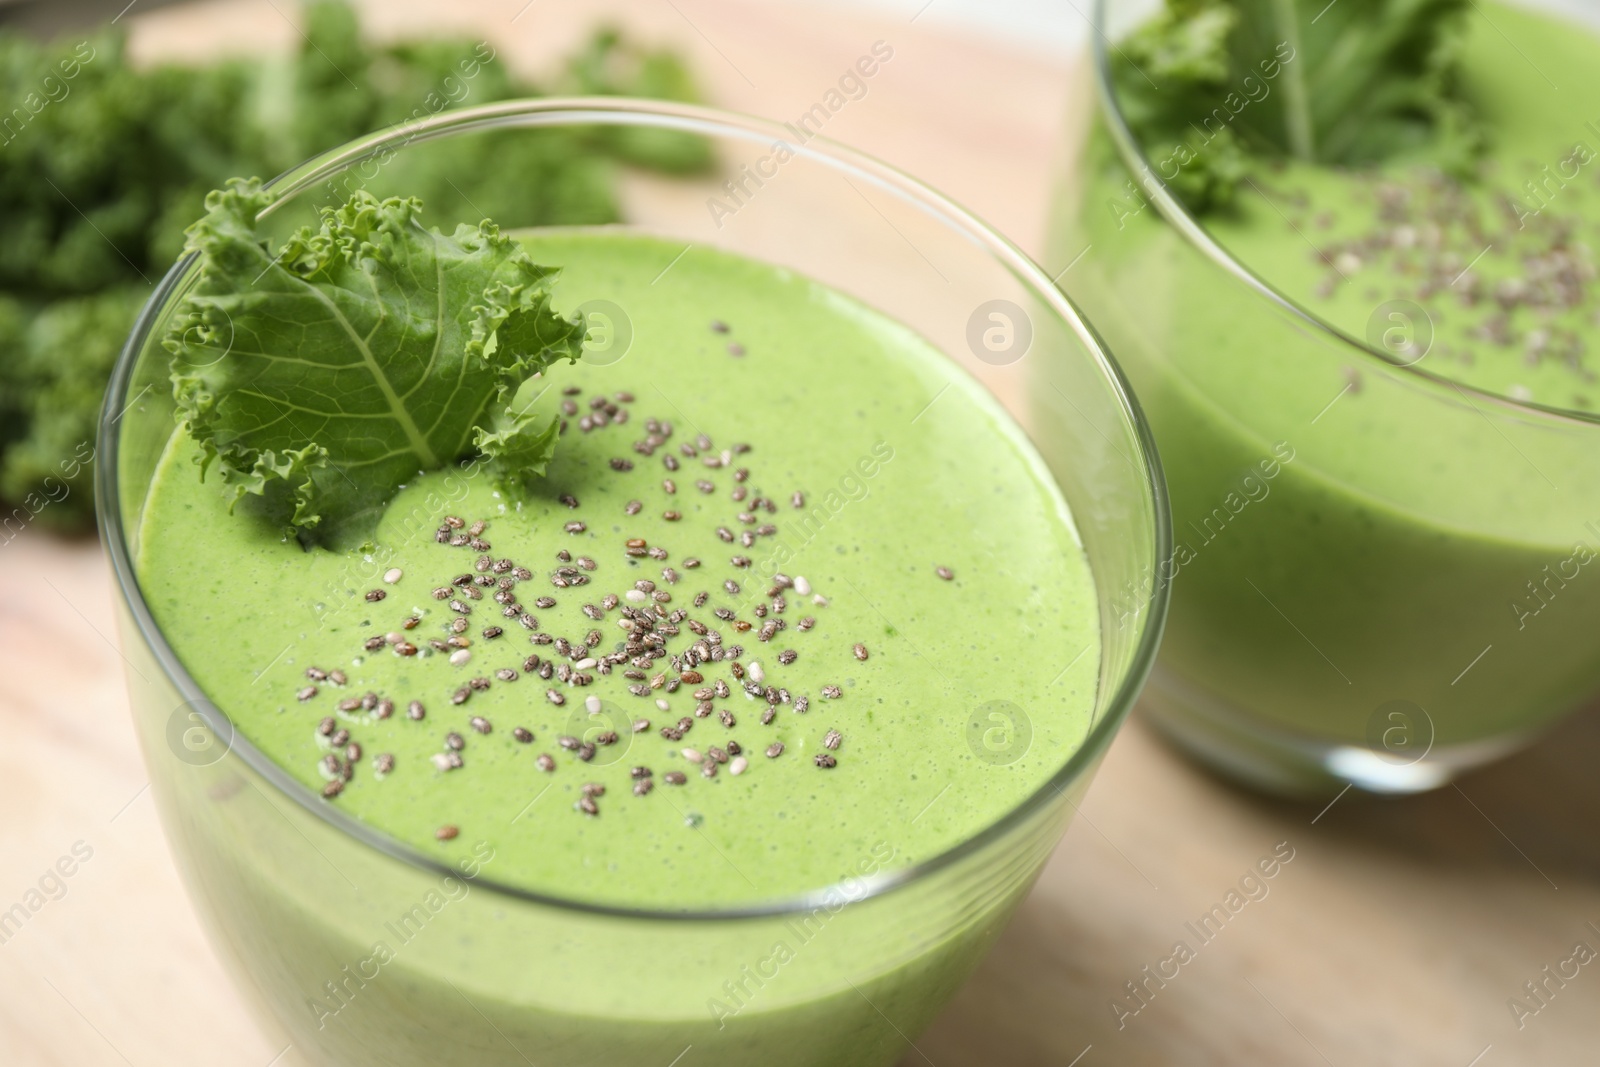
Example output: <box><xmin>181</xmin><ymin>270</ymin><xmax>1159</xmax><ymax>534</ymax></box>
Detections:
<box><xmin>138</xmin><ymin>232</ymin><xmax>1099</xmax><ymax>910</ymax></box>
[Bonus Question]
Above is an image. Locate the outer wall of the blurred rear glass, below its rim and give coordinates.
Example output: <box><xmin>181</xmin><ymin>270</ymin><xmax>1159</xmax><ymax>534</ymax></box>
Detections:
<box><xmin>1051</xmin><ymin>0</ymin><xmax>1600</xmax><ymax>797</ymax></box>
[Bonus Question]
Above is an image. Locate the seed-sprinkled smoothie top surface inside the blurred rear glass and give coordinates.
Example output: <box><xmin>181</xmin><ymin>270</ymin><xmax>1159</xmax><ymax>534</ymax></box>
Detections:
<box><xmin>1208</xmin><ymin>5</ymin><xmax>1600</xmax><ymax>413</ymax></box>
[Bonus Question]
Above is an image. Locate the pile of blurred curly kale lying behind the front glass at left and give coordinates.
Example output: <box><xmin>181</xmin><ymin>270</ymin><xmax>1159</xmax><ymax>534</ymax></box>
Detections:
<box><xmin>0</xmin><ymin>2</ymin><xmax>710</xmax><ymax>530</ymax></box>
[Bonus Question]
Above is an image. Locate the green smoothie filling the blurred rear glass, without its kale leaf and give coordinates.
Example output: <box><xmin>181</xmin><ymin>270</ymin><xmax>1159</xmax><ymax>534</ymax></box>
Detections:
<box><xmin>1058</xmin><ymin>5</ymin><xmax>1600</xmax><ymax>771</ymax></box>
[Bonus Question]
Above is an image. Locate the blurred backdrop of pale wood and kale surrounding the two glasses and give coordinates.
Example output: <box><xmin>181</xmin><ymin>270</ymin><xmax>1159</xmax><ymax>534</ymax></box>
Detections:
<box><xmin>0</xmin><ymin>0</ymin><xmax>1600</xmax><ymax>1067</ymax></box>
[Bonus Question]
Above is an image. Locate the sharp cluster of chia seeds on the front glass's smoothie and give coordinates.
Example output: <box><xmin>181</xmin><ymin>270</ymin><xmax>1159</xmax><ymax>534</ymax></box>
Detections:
<box><xmin>296</xmin><ymin>367</ymin><xmax>902</xmax><ymax>841</ymax></box>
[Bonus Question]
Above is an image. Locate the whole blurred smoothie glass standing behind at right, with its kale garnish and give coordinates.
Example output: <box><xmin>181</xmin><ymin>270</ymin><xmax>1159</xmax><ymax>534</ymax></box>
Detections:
<box><xmin>1053</xmin><ymin>0</ymin><xmax>1600</xmax><ymax>797</ymax></box>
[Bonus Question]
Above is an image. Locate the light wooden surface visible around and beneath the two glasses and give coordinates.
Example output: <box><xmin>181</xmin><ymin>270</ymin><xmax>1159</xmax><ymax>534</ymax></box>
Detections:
<box><xmin>0</xmin><ymin>0</ymin><xmax>1600</xmax><ymax>1067</ymax></box>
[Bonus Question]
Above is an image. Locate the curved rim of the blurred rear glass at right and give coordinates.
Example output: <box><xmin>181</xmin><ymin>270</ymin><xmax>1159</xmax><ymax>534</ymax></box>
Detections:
<box><xmin>1090</xmin><ymin>0</ymin><xmax>1600</xmax><ymax>426</ymax></box>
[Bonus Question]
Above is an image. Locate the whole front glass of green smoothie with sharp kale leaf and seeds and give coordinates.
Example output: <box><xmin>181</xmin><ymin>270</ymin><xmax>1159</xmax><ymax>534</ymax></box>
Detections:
<box><xmin>98</xmin><ymin>95</ymin><xmax>1170</xmax><ymax>1067</ymax></box>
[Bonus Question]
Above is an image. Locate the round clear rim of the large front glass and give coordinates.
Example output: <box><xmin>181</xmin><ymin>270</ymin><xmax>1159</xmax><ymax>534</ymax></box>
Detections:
<box><xmin>94</xmin><ymin>96</ymin><xmax>1173</xmax><ymax>921</ymax></box>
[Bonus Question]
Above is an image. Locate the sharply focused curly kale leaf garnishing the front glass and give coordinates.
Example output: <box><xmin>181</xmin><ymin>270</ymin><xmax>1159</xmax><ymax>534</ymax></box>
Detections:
<box><xmin>165</xmin><ymin>181</ymin><xmax>584</xmax><ymax>542</ymax></box>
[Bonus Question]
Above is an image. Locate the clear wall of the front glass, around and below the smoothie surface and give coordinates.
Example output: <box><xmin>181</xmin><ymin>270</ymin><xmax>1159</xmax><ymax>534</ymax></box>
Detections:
<box><xmin>98</xmin><ymin>98</ymin><xmax>1170</xmax><ymax>1067</ymax></box>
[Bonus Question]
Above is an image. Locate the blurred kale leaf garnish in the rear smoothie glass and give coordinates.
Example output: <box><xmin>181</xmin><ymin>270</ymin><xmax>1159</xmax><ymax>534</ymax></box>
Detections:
<box><xmin>1112</xmin><ymin>0</ymin><xmax>1483</xmax><ymax>211</ymax></box>
